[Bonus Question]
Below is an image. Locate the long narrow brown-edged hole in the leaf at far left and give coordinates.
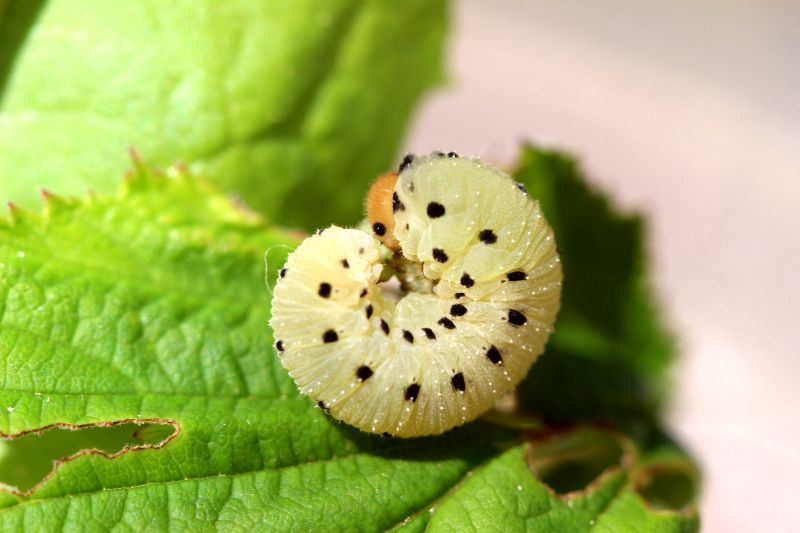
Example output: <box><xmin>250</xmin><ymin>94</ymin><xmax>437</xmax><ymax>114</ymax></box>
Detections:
<box><xmin>0</xmin><ymin>421</ymin><xmax>178</xmax><ymax>493</ymax></box>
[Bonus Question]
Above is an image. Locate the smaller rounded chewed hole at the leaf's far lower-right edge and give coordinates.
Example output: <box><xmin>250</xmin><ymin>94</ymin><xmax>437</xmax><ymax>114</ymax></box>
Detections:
<box><xmin>635</xmin><ymin>464</ymin><xmax>698</xmax><ymax>511</ymax></box>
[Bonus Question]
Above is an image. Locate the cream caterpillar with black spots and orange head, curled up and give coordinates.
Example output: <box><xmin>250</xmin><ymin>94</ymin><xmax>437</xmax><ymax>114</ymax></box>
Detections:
<box><xmin>270</xmin><ymin>152</ymin><xmax>562</xmax><ymax>437</ymax></box>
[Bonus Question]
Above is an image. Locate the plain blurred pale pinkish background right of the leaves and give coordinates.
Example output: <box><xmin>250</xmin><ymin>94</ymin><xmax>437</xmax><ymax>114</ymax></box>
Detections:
<box><xmin>407</xmin><ymin>0</ymin><xmax>800</xmax><ymax>532</ymax></box>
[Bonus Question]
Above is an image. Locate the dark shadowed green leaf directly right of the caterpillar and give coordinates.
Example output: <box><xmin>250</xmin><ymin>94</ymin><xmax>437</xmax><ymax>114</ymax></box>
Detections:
<box><xmin>514</xmin><ymin>146</ymin><xmax>673</xmax><ymax>421</ymax></box>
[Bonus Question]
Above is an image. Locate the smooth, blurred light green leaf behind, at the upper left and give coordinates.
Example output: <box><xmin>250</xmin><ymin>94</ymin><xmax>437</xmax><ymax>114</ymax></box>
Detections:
<box><xmin>0</xmin><ymin>0</ymin><xmax>446</xmax><ymax>228</ymax></box>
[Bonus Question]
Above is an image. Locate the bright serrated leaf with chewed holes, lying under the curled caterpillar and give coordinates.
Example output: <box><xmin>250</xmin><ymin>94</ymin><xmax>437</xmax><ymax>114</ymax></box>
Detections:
<box><xmin>0</xmin><ymin>164</ymin><xmax>696</xmax><ymax>532</ymax></box>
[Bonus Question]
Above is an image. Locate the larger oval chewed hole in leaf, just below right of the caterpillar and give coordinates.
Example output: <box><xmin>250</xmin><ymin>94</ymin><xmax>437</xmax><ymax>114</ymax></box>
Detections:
<box><xmin>528</xmin><ymin>428</ymin><xmax>630</xmax><ymax>495</ymax></box>
